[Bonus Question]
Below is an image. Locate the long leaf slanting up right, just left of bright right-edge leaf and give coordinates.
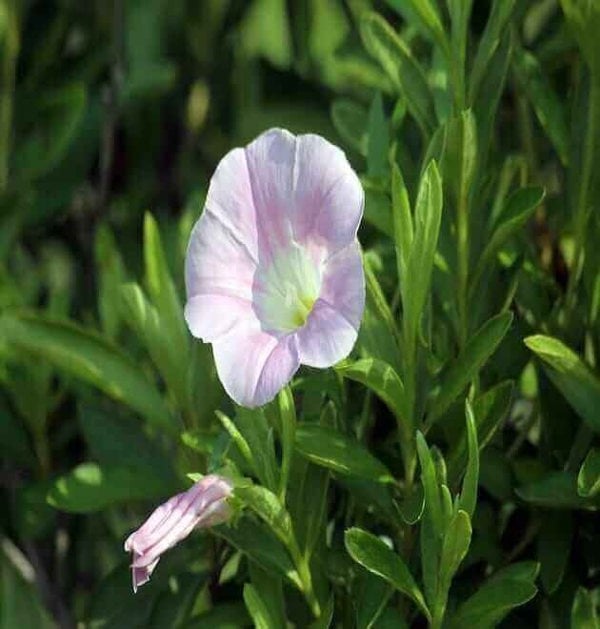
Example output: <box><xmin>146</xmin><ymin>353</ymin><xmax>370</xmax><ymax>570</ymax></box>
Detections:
<box><xmin>427</xmin><ymin>312</ymin><xmax>512</xmax><ymax>425</ymax></box>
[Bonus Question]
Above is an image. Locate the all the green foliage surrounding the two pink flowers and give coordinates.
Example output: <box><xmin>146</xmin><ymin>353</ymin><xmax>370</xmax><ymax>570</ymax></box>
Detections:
<box><xmin>0</xmin><ymin>0</ymin><xmax>600</xmax><ymax>629</ymax></box>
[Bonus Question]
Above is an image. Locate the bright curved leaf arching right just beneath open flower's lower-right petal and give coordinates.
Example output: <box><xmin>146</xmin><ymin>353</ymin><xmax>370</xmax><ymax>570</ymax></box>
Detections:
<box><xmin>336</xmin><ymin>358</ymin><xmax>404</xmax><ymax>422</ymax></box>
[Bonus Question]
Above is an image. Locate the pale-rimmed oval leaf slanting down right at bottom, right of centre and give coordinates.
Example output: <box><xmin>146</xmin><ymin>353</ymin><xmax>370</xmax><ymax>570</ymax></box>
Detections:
<box><xmin>344</xmin><ymin>528</ymin><xmax>430</xmax><ymax>619</ymax></box>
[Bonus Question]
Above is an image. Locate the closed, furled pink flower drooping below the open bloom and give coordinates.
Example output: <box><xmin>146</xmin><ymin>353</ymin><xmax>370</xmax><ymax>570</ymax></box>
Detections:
<box><xmin>125</xmin><ymin>474</ymin><xmax>232</xmax><ymax>592</ymax></box>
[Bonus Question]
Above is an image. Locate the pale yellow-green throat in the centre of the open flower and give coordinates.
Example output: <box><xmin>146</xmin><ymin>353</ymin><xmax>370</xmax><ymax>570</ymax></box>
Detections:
<box><xmin>254</xmin><ymin>245</ymin><xmax>321</xmax><ymax>332</ymax></box>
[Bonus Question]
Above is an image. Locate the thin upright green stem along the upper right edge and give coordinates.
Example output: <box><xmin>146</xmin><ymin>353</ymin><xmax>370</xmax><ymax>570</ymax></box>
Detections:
<box><xmin>566</xmin><ymin>77</ymin><xmax>600</xmax><ymax>307</ymax></box>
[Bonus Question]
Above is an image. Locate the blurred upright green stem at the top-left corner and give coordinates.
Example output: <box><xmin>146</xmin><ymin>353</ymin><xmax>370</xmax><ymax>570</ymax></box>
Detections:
<box><xmin>0</xmin><ymin>0</ymin><xmax>19</xmax><ymax>192</ymax></box>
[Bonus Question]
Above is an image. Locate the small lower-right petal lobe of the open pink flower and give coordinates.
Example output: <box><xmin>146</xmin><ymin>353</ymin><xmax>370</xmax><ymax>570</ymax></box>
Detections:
<box><xmin>295</xmin><ymin>299</ymin><xmax>358</xmax><ymax>368</ymax></box>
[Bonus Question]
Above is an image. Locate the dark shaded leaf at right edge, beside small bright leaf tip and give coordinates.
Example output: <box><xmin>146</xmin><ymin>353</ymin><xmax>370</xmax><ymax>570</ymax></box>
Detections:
<box><xmin>515</xmin><ymin>471</ymin><xmax>600</xmax><ymax>510</ymax></box>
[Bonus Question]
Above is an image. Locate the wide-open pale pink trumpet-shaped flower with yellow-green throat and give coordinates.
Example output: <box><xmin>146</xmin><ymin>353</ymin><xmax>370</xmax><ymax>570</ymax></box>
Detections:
<box><xmin>185</xmin><ymin>129</ymin><xmax>365</xmax><ymax>407</ymax></box>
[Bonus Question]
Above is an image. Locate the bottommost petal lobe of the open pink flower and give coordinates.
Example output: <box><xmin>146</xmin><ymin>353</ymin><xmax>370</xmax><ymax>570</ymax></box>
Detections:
<box><xmin>213</xmin><ymin>326</ymin><xmax>300</xmax><ymax>408</ymax></box>
